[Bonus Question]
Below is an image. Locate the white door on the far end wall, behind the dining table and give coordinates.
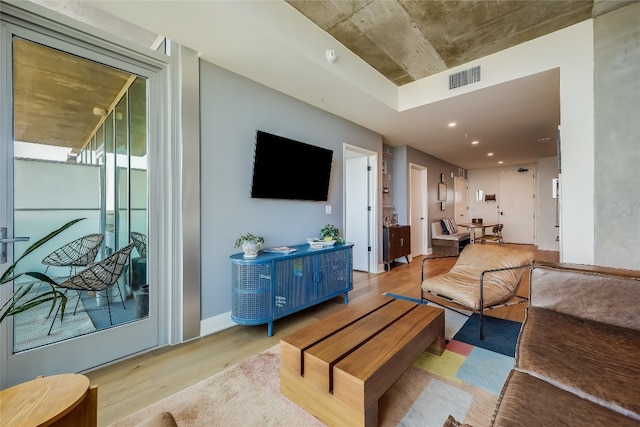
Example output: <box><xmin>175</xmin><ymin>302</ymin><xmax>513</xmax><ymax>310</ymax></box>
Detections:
<box><xmin>498</xmin><ymin>168</ymin><xmax>535</xmax><ymax>245</ymax></box>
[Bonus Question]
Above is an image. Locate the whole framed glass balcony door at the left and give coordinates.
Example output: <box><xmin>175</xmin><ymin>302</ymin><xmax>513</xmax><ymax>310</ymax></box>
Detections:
<box><xmin>0</xmin><ymin>6</ymin><xmax>166</xmax><ymax>388</ymax></box>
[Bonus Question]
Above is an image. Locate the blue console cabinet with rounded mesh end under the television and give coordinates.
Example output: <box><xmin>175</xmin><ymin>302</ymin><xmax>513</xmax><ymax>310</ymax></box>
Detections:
<box><xmin>230</xmin><ymin>243</ymin><xmax>353</xmax><ymax>336</ymax></box>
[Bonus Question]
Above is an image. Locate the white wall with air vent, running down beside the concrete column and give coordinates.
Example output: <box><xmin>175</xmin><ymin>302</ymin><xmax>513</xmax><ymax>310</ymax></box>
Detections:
<box><xmin>399</xmin><ymin>20</ymin><xmax>594</xmax><ymax>264</ymax></box>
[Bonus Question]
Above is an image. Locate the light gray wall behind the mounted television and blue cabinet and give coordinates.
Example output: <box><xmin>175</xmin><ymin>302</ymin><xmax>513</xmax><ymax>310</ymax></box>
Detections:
<box><xmin>200</xmin><ymin>61</ymin><xmax>382</xmax><ymax>319</ymax></box>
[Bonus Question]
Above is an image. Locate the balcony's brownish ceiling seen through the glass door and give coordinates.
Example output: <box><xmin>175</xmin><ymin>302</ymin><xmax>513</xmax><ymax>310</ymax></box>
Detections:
<box><xmin>13</xmin><ymin>38</ymin><xmax>131</xmax><ymax>153</ymax></box>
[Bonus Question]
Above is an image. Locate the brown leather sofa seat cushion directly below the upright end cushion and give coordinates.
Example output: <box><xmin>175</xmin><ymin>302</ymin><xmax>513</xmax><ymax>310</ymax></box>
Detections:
<box><xmin>516</xmin><ymin>308</ymin><xmax>640</xmax><ymax>425</ymax></box>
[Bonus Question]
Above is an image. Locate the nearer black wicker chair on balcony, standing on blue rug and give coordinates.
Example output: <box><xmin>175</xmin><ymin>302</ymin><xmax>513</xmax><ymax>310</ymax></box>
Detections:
<box><xmin>49</xmin><ymin>243</ymin><xmax>135</xmax><ymax>334</ymax></box>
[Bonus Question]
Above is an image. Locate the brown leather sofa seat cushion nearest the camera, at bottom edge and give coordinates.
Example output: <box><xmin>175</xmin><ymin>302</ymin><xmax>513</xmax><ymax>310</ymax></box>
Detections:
<box><xmin>492</xmin><ymin>370</ymin><xmax>632</xmax><ymax>427</ymax></box>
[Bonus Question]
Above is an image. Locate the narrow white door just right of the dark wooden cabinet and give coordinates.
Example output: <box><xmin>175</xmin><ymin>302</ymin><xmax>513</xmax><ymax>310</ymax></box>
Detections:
<box><xmin>409</xmin><ymin>164</ymin><xmax>428</xmax><ymax>257</ymax></box>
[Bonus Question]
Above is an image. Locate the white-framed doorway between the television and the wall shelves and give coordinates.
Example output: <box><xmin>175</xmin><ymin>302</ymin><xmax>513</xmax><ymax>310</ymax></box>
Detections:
<box><xmin>344</xmin><ymin>144</ymin><xmax>378</xmax><ymax>273</ymax></box>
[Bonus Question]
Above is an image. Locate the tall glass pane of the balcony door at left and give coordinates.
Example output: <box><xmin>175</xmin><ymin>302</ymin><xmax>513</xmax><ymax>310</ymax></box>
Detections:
<box><xmin>13</xmin><ymin>38</ymin><xmax>148</xmax><ymax>353</ymax></box>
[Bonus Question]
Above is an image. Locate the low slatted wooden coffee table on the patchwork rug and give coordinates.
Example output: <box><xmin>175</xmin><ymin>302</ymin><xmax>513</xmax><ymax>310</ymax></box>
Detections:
<box><xmin>280</xmin><ymin>295</ymin><xmax>445</xmax><ymax>426</ymax></box>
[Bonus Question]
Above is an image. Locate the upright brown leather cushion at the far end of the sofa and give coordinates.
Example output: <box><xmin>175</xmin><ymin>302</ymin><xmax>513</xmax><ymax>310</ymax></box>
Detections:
<box><xmin>530</xmin><ymin>262</ymin><xmax>640</xmax><ymax>330</ymax></box>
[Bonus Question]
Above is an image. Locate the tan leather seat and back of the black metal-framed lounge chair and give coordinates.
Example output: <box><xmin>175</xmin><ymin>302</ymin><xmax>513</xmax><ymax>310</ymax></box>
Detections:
<box><xmin>422</xmin><ymin>245</ymin><xmax>533</xmax><ymax>310</ymax></box>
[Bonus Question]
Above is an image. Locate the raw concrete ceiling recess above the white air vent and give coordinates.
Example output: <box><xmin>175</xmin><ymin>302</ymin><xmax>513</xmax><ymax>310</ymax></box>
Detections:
<box><xmin>286</xmin><ymin>0</ymin><xmax>593</xmax><ymax>85</ymax></box>
